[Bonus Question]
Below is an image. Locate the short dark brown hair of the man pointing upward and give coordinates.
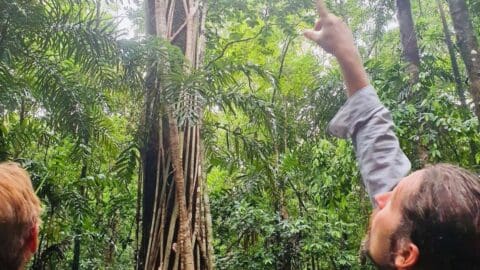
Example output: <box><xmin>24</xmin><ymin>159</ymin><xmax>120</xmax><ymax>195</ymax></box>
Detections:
<box><xmin>401</xmin><ymin>164</ymin><xmax>480</xmax><ymax>270</ymax></box>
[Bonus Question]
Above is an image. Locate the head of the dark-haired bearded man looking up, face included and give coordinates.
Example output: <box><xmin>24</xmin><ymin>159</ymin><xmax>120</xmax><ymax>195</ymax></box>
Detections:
<box><xmin>363</xmin><ymin>164</ymin><xmax>480</xmax><ymax>270</ymax></box>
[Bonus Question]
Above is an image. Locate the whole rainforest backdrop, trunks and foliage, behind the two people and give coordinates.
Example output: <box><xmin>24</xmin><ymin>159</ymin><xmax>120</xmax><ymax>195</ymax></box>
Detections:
<box><xmin>0</xmin><ymin>0</ymin><xmax>480</xmax><ymax>270</ymax></box>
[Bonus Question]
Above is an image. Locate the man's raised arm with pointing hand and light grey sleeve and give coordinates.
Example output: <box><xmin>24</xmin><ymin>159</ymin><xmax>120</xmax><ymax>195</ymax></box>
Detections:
<box><xmin>304</xmin><ymin>0</ymin><xmax>411</xmax><ymax>204</ymax></box>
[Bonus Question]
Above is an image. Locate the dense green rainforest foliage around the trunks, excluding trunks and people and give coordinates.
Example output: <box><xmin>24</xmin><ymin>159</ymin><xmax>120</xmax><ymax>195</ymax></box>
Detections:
<box><xmin>0</xmin><ymin>0</ymin><xmax>480</xmax><ymax>269</ymax></box>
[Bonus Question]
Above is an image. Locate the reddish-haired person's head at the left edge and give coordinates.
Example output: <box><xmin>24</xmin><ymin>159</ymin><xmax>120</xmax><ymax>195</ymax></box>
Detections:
<box><xmin>0</xmin><ymin>163</ymin><xmax>41</xmax><ymax>270</ymax></box>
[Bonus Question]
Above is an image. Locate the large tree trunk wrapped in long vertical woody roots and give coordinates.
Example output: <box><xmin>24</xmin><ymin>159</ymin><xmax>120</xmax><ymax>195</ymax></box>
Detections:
<box><xmin>137</xmin><ymin>0</ymin><xmax>214</xmax><ymax>270</ymax></box>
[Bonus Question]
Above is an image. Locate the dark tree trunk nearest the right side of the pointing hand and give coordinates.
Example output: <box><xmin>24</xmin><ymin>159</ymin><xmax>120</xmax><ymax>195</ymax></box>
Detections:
<box><xmin>397</xmin><ymin>0</ymin><xmax>420</xmax><ymax>84</ymax></box>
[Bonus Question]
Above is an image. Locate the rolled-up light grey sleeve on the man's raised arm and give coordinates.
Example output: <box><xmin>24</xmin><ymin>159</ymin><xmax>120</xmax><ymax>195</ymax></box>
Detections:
<box><xmin>328</xmin><ymin>86</ymin><xmax>411</xmax><ymax>205</ymax></box>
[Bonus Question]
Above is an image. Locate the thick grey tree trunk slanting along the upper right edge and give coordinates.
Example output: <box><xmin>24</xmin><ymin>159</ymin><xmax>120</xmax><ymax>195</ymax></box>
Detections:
<box><xmin>448</xmin><ymin>0</ymin><xmax>480</xmax><ymax>119</ymax></box>
